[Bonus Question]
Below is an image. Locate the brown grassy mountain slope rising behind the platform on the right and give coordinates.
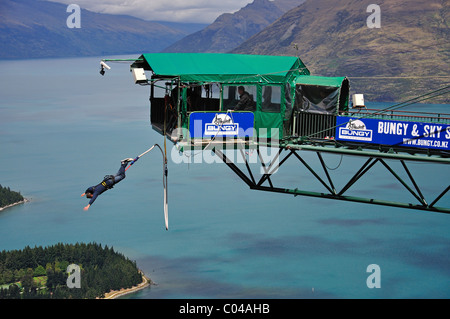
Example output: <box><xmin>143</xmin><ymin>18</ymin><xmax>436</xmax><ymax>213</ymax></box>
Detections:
<box><xmin>232</xmin><ymin>0</ymin><xmax>450</xmax><ymax>103</ymax></box>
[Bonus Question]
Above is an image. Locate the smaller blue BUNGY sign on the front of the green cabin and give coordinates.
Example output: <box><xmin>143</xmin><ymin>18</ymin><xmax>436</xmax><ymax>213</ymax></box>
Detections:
<box><xmin>189</xmin><ymin>112</ymin><xmax>255</xmax><ymax>139</ymax></box>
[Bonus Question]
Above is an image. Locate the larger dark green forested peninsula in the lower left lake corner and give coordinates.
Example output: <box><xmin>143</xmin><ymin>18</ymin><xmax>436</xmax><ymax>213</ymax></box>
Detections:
<box><xmin>0</xmin><ymin>243</ymin><xmax>146</xmax><ymax>299</ymax></box>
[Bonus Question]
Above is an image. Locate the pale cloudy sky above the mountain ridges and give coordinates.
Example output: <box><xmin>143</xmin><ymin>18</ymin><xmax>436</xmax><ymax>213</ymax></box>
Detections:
<box><xmin>51</xmin><ymin>0</ymin><xmax>253</xmax><ymax>24</ymax></box>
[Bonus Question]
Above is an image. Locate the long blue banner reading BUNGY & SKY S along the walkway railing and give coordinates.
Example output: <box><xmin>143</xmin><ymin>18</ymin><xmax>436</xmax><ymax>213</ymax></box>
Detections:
<box><xmin>336</xmin><ymin>116</ymin><xmax>450</xmax><ymax>151</ymax></box>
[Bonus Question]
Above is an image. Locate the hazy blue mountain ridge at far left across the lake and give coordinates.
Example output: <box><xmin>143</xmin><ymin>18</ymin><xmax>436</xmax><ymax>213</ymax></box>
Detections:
<box><xmin>0</xmin><ymin>0</ymin><xmax>186</xmax><ymax>59</ymax></box>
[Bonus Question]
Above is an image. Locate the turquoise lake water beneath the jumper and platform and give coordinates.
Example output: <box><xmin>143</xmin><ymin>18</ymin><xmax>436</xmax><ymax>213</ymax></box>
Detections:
<box><xmin>0</xmin><ymin>56</ymin><xmax>450</xmax><ymax>298</ymax></box>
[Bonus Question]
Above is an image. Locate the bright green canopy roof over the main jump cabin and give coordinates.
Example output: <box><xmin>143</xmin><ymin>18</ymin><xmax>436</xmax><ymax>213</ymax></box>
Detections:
<box><xmin>132</xmin><ymin>53</ymin><xmax>309</xmax><ymax>83</ymax></box>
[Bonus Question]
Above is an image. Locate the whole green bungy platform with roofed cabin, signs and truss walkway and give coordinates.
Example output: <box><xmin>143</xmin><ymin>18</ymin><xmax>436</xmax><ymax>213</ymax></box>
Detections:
<box><xmin>96</xmin><ymin>53</ymin><xmax>450</xmax><ymax>230</ymax></box>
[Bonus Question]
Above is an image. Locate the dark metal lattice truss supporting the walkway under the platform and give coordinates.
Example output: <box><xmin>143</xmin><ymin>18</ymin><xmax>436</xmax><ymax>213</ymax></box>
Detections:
<box><xmin>213</xmin><ymin>145</ymin><xmax>450</xmax><ymax>214</ymax></box>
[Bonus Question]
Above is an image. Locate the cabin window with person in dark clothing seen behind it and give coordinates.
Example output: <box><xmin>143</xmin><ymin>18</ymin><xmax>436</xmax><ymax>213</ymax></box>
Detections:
<box><xmin>222</xmin><ymin>84</ymin><xmax>257</xmax><ymax>112</ymax></box>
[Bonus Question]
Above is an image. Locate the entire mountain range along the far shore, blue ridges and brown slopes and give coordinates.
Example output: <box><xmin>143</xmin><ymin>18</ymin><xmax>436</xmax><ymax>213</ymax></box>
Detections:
<box><xmin>0</xmin><ymin>0</ymin><xmax>450</xmax><ymax>103</ymax></box>
